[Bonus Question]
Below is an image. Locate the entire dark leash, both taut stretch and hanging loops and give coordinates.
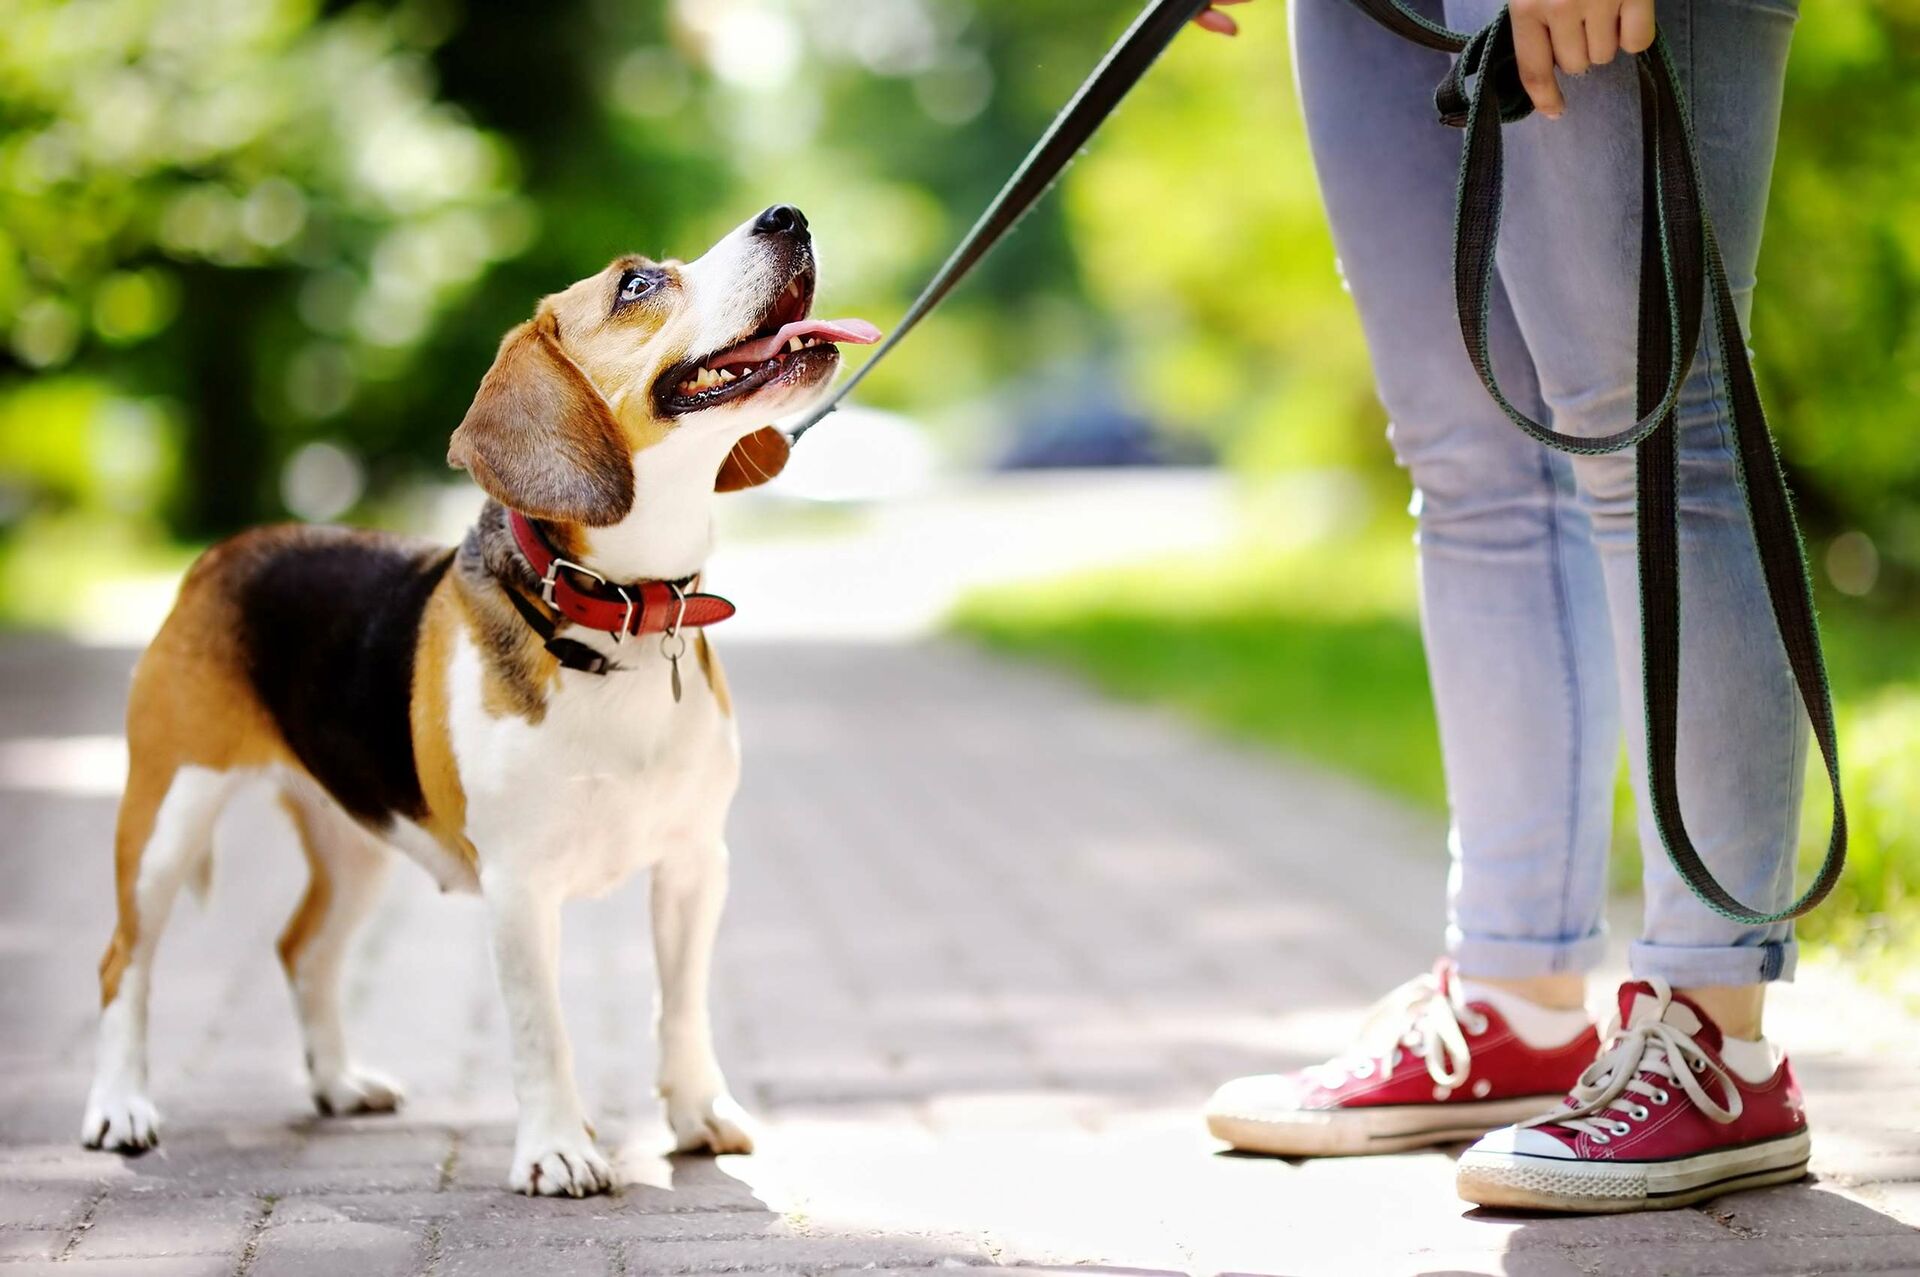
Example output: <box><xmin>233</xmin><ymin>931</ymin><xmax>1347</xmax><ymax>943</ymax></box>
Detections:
<box><xmin>793</xmin><ymin>0</ymin><xmax>1847</xmax><ymax>926</ymax></box>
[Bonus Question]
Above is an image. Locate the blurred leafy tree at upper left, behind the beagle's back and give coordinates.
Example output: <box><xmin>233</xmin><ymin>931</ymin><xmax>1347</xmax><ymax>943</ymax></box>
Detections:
<box><xmin>0</xmin><ymin>0</ymin><xmax>530</xmax><ymax>536</ymax></box>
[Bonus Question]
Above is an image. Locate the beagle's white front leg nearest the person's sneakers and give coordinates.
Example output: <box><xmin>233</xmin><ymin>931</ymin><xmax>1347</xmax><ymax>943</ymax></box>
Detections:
<box><xmin>653</xmin><ymin>841</ymin><xmax>753</xmax><ymax>1152</ymax></box>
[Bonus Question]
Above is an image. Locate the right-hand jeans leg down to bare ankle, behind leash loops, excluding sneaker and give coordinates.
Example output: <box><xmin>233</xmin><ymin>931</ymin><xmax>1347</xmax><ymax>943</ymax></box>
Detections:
<box><xmin>1448</xmin><ymin>0</ymin><xmax>1807</xmax><ymax>1006</ymax></box>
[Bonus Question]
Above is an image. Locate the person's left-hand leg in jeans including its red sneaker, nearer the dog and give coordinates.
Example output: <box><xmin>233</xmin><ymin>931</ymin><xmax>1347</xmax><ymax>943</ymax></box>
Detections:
<box><xmin>1206</xmin><ymin>0</ymin><xmax>1619</xmax><ymax>1156</ymax></box>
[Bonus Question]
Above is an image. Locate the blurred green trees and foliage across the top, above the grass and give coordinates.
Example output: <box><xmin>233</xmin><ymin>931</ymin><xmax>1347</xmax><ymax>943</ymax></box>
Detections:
<box><xmin>0</xmin><ymin>0</ymin><xmax>1920</xmax><ymax>603</ymax></box>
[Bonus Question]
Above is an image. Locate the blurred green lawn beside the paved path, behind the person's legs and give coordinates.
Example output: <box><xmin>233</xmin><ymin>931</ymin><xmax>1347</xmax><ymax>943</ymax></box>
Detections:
<box><xmin>954</xmin><ymin>524</ymin><xmax>1920</xmax><ymax>974</ymax></box>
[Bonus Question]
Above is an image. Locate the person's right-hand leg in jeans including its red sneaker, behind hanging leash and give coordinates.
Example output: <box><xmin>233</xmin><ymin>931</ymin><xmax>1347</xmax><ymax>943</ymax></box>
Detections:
<box><xmin>1448</xmin><ymin>0</ymin><xmax>1809</xmax><ymax>1212</ymax></box>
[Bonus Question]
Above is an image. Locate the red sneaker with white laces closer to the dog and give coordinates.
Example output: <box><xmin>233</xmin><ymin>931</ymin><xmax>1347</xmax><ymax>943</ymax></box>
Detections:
<box><xmin>1206</xmin><ymin>960</ymin><xmax>1599</xmax><ymax>1156</ymax></box>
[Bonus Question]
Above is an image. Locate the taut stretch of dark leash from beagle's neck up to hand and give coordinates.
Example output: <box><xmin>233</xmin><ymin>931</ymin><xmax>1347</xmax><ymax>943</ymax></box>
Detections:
<box><xmin>789</xmin><ymin>0</ymin><xmax>1208</xmax><ymax>442</ymax></box>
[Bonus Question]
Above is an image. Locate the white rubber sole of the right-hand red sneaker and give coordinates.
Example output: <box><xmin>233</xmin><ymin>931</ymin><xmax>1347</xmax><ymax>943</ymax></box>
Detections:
<box><xmin>1455</xmin><ymin>1131</ymin><xmax>1812</xmax><ymax>1214</ymax></box>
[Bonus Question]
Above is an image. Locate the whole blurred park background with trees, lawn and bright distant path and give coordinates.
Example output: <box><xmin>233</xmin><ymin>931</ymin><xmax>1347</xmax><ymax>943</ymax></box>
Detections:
<box><xmin>0</xmin><ymin>0</ymin><xmax>1920</xmax><ymax>975</ymax></box>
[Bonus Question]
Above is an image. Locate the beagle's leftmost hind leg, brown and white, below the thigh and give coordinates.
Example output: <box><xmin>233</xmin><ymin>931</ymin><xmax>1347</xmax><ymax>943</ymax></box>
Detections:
<box><xmin>81</xmin><ymin>751</ymin><xmax>236</xmax><ymax>1152</ymax></box>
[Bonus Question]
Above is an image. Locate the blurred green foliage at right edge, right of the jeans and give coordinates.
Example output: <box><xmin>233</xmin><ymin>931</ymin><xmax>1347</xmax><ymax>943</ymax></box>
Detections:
<box><xmin>1753</xmin><ymin>0</ymin><xmax>1920</xmax><ymax>572</ymax></box>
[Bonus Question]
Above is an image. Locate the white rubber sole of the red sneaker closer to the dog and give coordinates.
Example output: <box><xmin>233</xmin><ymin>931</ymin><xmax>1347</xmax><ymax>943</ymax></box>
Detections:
<box><xmin>1206</xmin><ymin>1091</ymin><xmax>1565</xmax><ymax>1158</ymax></box>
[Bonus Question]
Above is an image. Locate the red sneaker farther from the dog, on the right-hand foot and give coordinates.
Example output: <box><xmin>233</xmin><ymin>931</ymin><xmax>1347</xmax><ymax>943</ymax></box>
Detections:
<box><xmin>1459</xmin><ymin>979</ymin><xmax>1809</xmax><ymax>1212</ymax></box>
